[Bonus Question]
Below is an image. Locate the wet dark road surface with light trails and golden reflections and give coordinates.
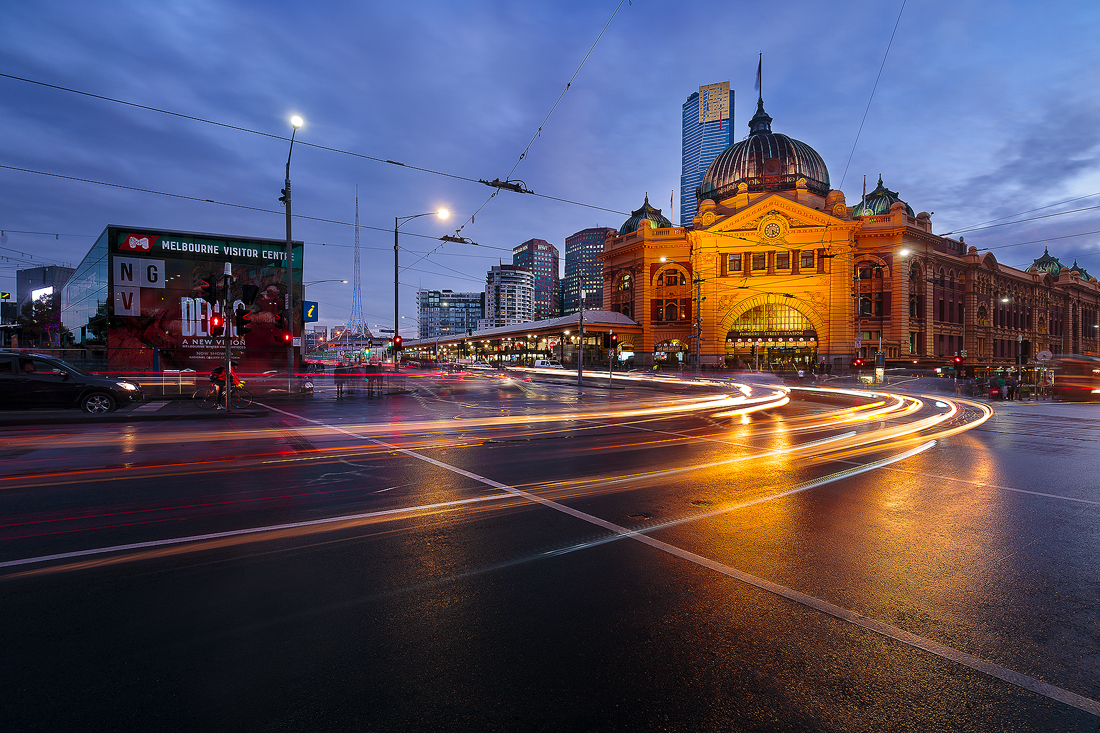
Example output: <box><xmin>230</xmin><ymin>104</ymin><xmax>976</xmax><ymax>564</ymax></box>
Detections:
<box><xmin>0</xmin><ymin>378</ymin><xmax>1100</xmax><ymax>731</ymax></box>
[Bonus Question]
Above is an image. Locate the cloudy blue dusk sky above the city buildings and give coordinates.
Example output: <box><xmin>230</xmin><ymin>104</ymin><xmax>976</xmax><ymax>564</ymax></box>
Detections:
<box><xmin>0</xmin><ymin>0</ymin><xmax>1100</xmax><ymax>336</ymax></box>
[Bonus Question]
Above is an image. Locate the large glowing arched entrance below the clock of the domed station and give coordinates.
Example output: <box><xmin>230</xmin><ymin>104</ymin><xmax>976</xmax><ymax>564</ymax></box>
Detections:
<box><xmin>726</xmin><ymin>303</ymin><xmax>817</xmax><ymax>371</ymax></box>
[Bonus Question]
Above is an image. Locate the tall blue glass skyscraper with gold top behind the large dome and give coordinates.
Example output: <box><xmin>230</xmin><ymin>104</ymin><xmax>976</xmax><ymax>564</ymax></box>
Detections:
<box><xmin>680</xmin><ymin>81</ymin><xmax>733</xmax><ymax>227</ymax></box>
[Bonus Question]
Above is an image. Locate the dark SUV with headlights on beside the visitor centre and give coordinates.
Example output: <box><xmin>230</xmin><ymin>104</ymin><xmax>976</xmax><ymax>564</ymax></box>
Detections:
<box><xmin>0</xmin><ymin>351</ymin><xmax>144</xmax><ymax>413</ymax></box>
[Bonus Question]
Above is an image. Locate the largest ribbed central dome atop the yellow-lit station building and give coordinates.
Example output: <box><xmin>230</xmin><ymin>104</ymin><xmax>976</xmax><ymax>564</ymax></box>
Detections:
<box><xmin>695</xmin><ymin>99</ymin><xmax>829</xmax><ymax>201</ymax></box>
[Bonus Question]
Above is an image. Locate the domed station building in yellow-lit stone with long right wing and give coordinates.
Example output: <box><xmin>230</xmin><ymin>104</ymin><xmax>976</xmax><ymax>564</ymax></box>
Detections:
<box><xmin>603</xmin><ymin>95</ymin><xmax>1100</xmax><ymax>375</ymax></box>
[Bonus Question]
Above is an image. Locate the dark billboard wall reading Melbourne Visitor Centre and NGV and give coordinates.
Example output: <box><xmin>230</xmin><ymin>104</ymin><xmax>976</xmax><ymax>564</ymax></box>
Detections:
<box><xmin>108</xmin><ymin>227</ymin><xmax>303</xmax><ymax>373</ymax></box>
